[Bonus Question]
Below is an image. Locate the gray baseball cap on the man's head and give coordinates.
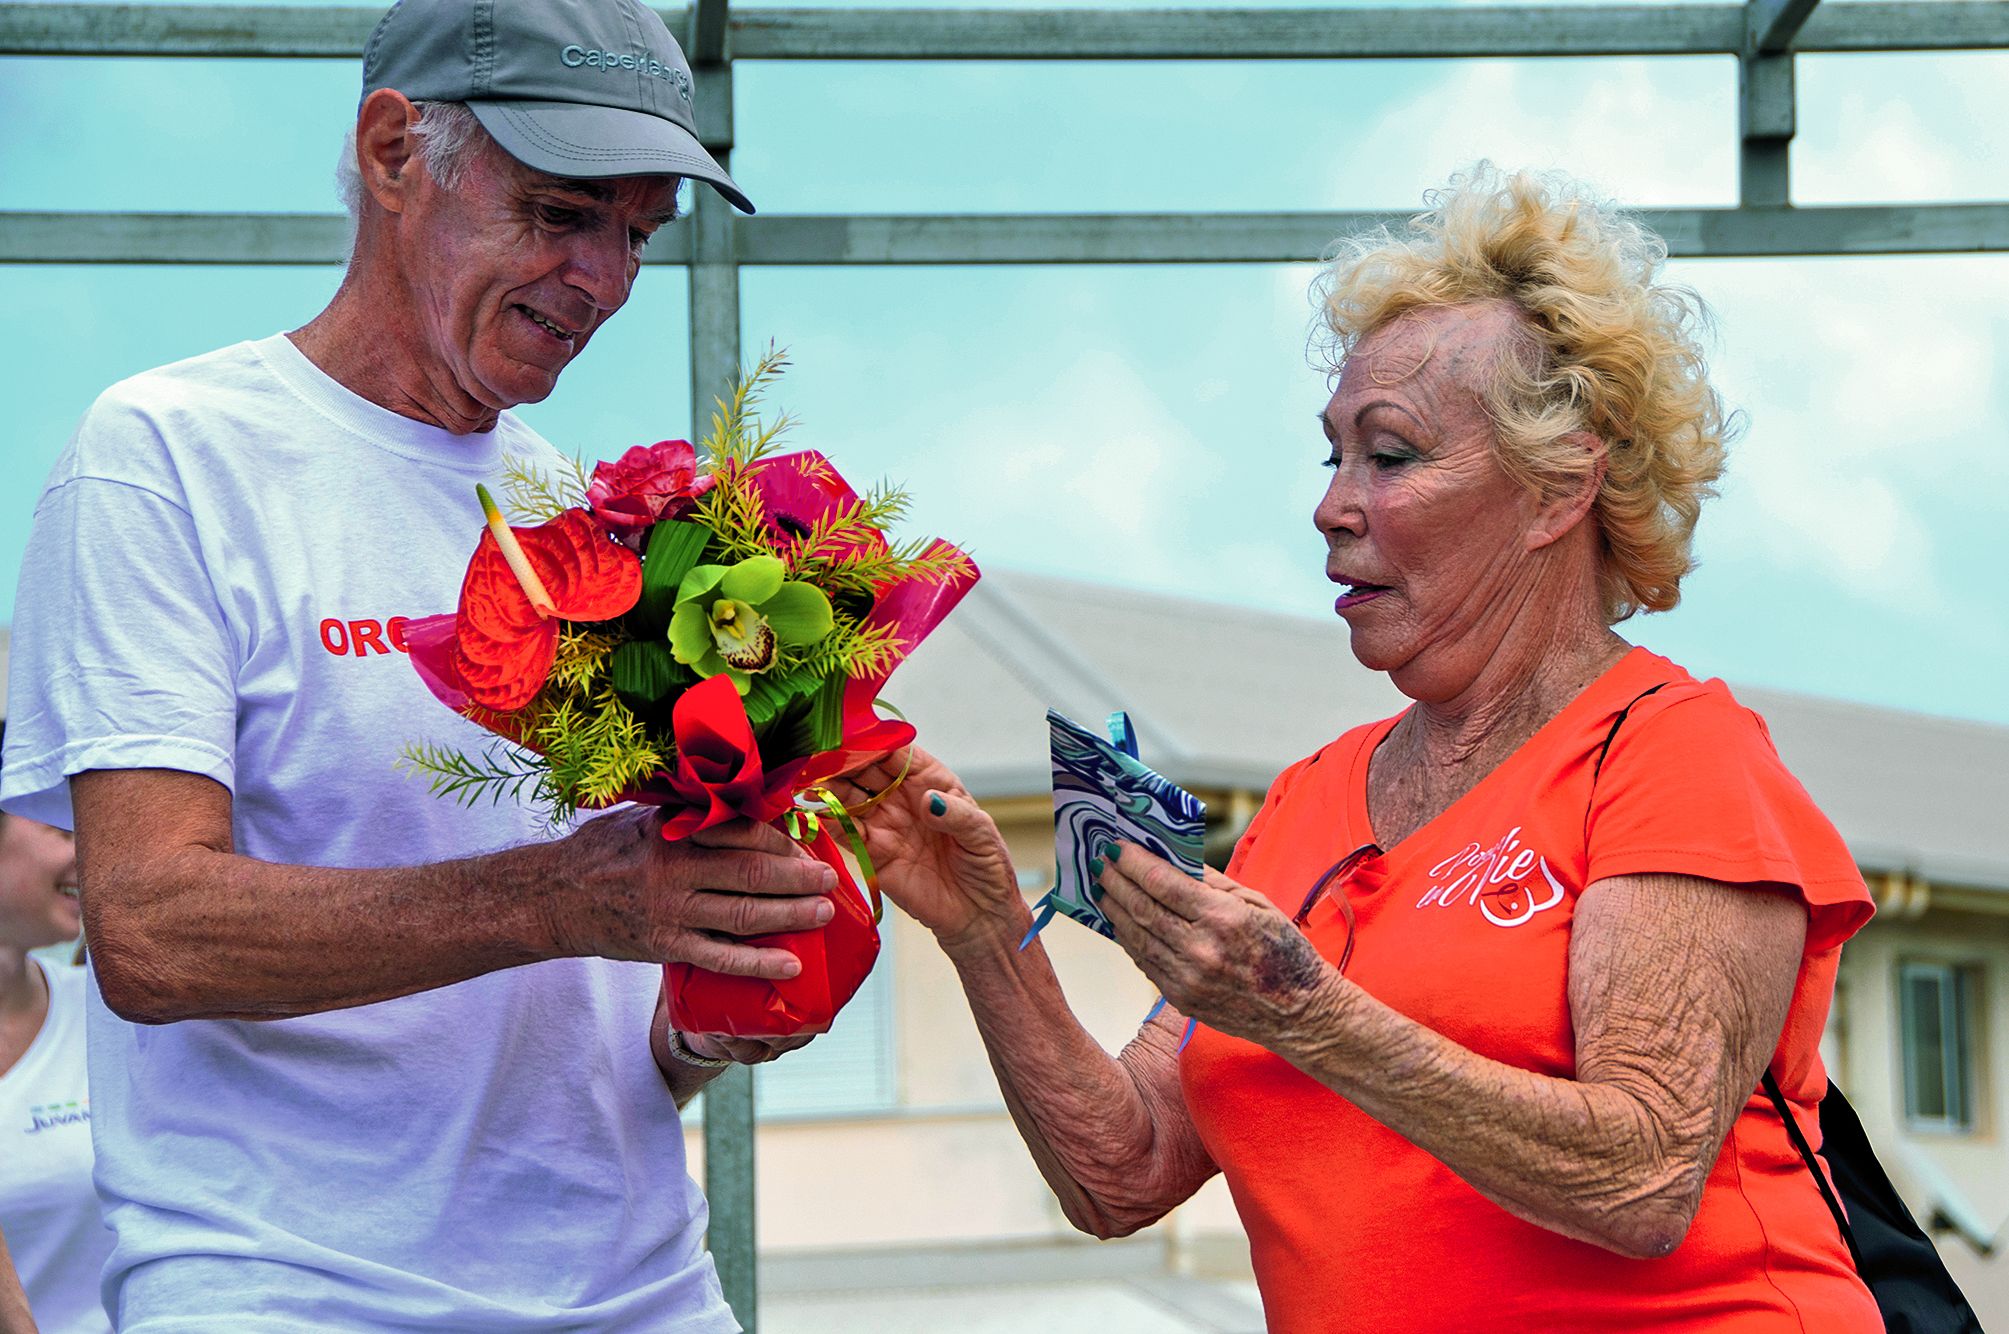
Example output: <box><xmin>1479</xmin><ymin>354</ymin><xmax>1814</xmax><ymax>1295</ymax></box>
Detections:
<box><xmin>364</xmin><ymin>0</ymin><xmax>753</xmax><ymax>213</ymax></box>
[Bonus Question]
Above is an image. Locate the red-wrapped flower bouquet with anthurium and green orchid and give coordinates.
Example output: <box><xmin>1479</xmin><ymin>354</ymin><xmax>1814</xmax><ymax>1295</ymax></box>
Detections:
<box><xmin>404</xmin><ymin>352</ymin><xmax>976</xmax><ymax>1037</ymax></box>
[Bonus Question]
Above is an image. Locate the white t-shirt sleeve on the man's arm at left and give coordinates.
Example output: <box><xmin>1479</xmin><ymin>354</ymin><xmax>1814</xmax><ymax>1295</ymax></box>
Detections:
<box><xmin>0</xmin><ymin>400</ymin><xmax>237</xmax><ymax>828</ymax></box>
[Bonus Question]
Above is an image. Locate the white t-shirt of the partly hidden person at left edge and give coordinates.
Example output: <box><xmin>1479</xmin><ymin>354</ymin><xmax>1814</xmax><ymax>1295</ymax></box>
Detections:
<box><xmin>0</xmin><ymin>958</ymin><xmax>113</xmax><ymax>1334</ymax></box>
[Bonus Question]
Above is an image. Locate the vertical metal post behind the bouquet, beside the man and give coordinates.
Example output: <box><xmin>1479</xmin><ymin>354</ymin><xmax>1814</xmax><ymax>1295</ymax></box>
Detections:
<box><xmin>687</xmin><ymin>0</ymin><xmax>759</xmax><ymax>1334</ymax></box>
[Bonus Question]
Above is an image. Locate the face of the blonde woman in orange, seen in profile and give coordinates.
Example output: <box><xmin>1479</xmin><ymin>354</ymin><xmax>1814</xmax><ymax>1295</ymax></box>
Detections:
<box><xmin>1312</xmin><ymin>303</ymin><xmax>1541</xmax><ymax>701</ymax></box>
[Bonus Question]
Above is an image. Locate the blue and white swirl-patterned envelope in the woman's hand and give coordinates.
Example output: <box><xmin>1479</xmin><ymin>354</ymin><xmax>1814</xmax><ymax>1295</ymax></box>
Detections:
<box><xmin>1027</xmin><ymin>709</ymin><xmax>1207</xmax><ymax>940</ymax></box>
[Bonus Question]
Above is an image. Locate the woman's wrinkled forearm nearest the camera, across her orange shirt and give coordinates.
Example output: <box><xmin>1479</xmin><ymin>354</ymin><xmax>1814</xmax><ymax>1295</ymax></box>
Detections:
<box><xmin>1278</xmin><ymin>974</ymin><xmax>1722</xmax><ymax>1258</ymax></box>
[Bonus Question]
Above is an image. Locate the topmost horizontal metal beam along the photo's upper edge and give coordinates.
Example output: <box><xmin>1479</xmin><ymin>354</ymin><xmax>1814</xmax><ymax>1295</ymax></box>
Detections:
<box><xmin>0</xmin><ymin>0</ymin><xmax>2009</xmax><ymax>60</ymax></box>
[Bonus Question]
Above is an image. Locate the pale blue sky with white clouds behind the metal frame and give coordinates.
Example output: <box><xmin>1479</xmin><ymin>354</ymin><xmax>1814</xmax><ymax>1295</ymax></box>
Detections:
<box><xmin>0</xmin><ymin>0</ymin><xmax>2009</xmax><ymax>725</ymax></box>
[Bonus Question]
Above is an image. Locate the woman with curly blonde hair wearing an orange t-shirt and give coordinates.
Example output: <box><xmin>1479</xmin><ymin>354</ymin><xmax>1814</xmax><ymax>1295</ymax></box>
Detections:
<box><xmin>860</xmin><ymin>169</ymin><xmax>1882</xmax><ymax>1334</ymax></box>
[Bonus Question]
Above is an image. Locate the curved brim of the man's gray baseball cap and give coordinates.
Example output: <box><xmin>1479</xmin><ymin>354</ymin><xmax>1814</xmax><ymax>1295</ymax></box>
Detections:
<box><xmin>468</xmin><ymin>102</ymin><xmax>753</xmax><ymax>213</ymax></box>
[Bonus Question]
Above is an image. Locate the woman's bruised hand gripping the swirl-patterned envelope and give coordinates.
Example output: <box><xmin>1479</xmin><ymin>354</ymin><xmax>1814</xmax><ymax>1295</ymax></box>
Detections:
<box><xmin>1101</xmin><ymin>844</ymin><xmax>1340</xmax><ymax>1051</ymax></box>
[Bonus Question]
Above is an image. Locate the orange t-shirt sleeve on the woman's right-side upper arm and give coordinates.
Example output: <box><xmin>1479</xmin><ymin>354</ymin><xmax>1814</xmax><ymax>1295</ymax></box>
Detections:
<box><xmin>1585</xmin><ymin>687</ymin><xmax>1874</xmax><ymax>952</ymax></box>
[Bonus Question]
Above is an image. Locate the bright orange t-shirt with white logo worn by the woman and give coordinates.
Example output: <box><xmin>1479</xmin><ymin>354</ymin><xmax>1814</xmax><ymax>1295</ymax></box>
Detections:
<box><xmin>1179</xmin><ymin>649</ymin><xmax>1882</xmax><ymax>1334</ymax></box>
